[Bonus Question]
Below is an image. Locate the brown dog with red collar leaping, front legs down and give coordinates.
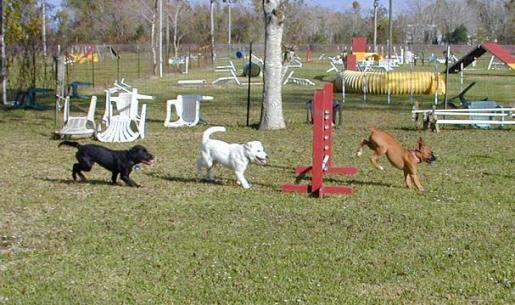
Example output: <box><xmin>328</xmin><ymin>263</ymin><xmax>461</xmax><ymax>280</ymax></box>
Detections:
<box><xmin>357</xmin><ymin>128</ymin><xmax>436</xmax><ymax>192</ymax></box>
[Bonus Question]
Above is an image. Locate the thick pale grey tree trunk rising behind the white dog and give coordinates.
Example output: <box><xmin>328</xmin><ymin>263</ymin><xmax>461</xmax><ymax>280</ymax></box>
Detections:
<box><xmin>259</xmin><ymin>0</ymin><xmax>287</xmax><ymax>129</ymax></box>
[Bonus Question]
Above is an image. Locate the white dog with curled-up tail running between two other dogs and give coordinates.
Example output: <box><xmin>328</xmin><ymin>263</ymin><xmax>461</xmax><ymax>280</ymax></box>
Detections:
<box><xmin>197</xmin><ymin>126</ymin><xmax>268</xmax><ymax>189</ymax></box>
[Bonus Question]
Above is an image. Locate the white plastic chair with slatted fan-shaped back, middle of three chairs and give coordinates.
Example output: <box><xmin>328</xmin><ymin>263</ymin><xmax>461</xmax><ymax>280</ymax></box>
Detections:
<box><xmin>97</xmin><ymin>83</ymin><xmax>153</xmax><ymax>142</ymax></box>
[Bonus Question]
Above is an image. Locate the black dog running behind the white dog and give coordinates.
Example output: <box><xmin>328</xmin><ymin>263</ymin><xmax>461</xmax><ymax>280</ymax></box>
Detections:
<box><xmin>58</xmin><ymin>141</ymin><xmax>154</xmax><ymax>187</ymax></box>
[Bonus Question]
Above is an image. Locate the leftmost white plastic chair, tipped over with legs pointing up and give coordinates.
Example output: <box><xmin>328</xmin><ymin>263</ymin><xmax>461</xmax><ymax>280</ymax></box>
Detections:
<box><xmin>55</xmin><ymin>96</ymin><xmax>97</xmax><ymax>137</ymax></box>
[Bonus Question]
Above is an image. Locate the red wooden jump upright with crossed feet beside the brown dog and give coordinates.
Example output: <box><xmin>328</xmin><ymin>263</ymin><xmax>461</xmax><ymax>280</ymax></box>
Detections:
<box><xmin>282</xmin><ymin>83</ymin><xmax>358</xmax><ymax>197</ymax></box>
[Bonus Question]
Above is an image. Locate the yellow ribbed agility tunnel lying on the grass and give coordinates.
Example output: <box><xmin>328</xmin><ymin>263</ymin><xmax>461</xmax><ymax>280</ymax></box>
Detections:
<box><xmin>334</xmin><ymin>70</ymin><xmax>445</xmax><ymax>95</ymax></box>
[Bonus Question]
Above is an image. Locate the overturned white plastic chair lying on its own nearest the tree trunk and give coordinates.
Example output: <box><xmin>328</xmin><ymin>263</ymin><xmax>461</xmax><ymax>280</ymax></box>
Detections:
<box><xmin>164</xmin><ymin>95</ymin><xmax>213</xmax><ymax>128</ymax></box>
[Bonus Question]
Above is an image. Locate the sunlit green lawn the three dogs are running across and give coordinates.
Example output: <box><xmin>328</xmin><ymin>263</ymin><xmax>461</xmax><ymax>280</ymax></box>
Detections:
<box><xmin>0</xmin><ymin>57</ymin><xmax>515</xmax><ymax>304</ymax></box>
